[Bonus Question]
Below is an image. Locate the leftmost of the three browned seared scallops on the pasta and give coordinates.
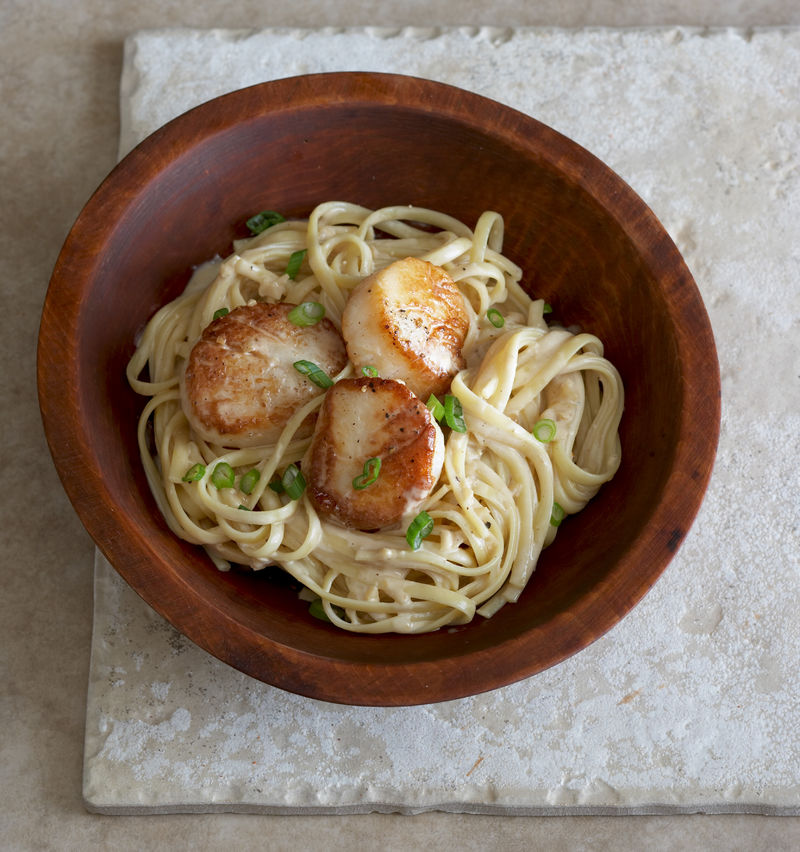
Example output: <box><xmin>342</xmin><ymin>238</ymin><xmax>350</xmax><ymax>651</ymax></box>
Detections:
<box><xmin>181</xmin><ymin>303</ymin><xmax>347</xmax><ymax>447</ymax></box>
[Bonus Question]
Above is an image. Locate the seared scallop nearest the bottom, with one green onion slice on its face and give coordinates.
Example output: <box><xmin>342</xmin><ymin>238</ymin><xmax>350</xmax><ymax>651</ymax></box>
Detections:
<box><xmin>303</xmin><ymin>378</ymin><xmax>444</xmax><ymax>530</ymax></box>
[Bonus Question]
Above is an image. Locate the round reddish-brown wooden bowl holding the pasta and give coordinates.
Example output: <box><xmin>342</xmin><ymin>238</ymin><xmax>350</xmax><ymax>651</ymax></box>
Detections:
<box><xmin>38</xmin><ymin>73</ymin><xmax>719</xmax><ymax>705</ymax></box>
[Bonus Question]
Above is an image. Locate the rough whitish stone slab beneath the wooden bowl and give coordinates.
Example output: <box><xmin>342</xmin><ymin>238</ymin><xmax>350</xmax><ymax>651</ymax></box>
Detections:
<box><xmin>84</xmin><ymin>29</ymin><xmax>800</xmax><ymax>814</ymax></box>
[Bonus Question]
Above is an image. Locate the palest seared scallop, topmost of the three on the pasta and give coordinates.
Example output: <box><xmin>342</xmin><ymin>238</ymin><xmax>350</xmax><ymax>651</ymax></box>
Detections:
<box><xmin>342</xmin><ymin>257</ymin><xmax>469</xmax><ymax>400</ymax></box>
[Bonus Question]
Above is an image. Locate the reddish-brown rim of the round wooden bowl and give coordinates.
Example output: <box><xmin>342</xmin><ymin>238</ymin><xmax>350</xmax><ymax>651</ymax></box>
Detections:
<box><xmin>38</xmin><ymin>72</ymin><xmax>720</xmax><ymax>706</ymax></box>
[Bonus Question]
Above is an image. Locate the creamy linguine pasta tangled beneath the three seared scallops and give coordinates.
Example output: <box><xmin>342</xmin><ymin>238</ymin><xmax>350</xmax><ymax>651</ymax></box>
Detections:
<box><xmin>127</xmin><ymin>202</ymin><xmax>623</xmax><ymax>633</ymax></box>
